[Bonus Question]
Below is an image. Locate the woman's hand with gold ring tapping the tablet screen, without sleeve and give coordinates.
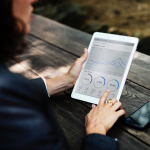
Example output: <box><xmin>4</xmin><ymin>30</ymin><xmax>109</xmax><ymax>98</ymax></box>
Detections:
<box><xmin>85</xmin><ymin>91</ymin><xmax>125</xmax><ymax>135</ymax></box>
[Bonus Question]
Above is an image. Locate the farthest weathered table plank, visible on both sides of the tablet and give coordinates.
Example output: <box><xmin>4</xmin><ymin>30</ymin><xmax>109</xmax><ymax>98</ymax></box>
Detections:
<box><xmin>30</xmin><ymin>15</ymin><xmax>150</xmax><ymax>89</ymax></box>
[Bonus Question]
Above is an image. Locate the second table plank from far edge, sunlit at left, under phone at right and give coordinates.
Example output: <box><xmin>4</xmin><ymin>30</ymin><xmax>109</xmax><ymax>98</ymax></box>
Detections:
<box><xmin>20</xmin><ymin>36</ymin><xmax>150</xmax><ymax>144</ymax></box>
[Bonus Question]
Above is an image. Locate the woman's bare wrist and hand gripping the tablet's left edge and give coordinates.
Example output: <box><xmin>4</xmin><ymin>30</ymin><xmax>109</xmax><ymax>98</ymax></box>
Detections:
<box><xmin>46</xmin><ymin>49</ymin><xmax>88</xmax><ymax>95</ymax></box>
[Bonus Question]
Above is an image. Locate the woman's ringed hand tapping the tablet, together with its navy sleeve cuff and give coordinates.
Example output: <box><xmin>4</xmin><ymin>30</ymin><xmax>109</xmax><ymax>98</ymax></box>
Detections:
<box><xmin>81</xmin><ymin>91</ymin><xmax>125</xmax><ymax>150</ymax></box>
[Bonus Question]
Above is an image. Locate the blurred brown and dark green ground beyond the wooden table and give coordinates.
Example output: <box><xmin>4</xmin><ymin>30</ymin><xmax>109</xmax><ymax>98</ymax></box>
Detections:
<box><xmin>34</xmin><ymin>0</ymin><xmax>150</xmax><ymax>55</ymax></box>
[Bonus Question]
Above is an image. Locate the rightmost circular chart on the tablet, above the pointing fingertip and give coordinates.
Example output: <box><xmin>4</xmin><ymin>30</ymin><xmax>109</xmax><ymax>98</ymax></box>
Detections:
<box><xmin>107</xmin><ymin>79</ymin><xmax>119</xmax><ymax>92</ymax></box>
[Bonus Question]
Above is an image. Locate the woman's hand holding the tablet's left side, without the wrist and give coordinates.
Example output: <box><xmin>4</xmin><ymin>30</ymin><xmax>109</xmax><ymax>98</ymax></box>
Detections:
<box><xmin>66</xmin><ymin>48</ymin><xmax>88</xmax><ymax>85</ymax></box>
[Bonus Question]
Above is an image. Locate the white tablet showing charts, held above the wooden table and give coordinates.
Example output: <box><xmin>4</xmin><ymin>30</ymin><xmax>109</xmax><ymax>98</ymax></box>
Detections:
<box><xmin>71</xmin><ymin>32</ymin><xmax>139</xmax><ymax>104</ymax></box>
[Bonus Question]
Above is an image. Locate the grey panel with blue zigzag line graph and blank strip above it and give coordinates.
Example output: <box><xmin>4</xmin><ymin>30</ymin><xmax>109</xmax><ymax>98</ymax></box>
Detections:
<box><xmin>85</xmin><ymin>48</ymin><xmax>130</xmax><ymax>76</ymax></box>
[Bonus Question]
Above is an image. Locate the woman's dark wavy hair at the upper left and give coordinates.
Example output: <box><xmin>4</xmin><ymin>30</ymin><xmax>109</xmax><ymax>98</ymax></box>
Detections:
<box><xmin>0</xmin><ymin>0</ymin><xmax>27</xmax><ymax>62</ymax></box>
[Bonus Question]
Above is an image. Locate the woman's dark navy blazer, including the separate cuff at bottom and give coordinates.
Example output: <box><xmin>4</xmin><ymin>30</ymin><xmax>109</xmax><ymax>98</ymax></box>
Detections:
<box><xmin>0</xmin><ymin>64</ymin><xmax>117</xmax><ymax>150</ymax></box>
